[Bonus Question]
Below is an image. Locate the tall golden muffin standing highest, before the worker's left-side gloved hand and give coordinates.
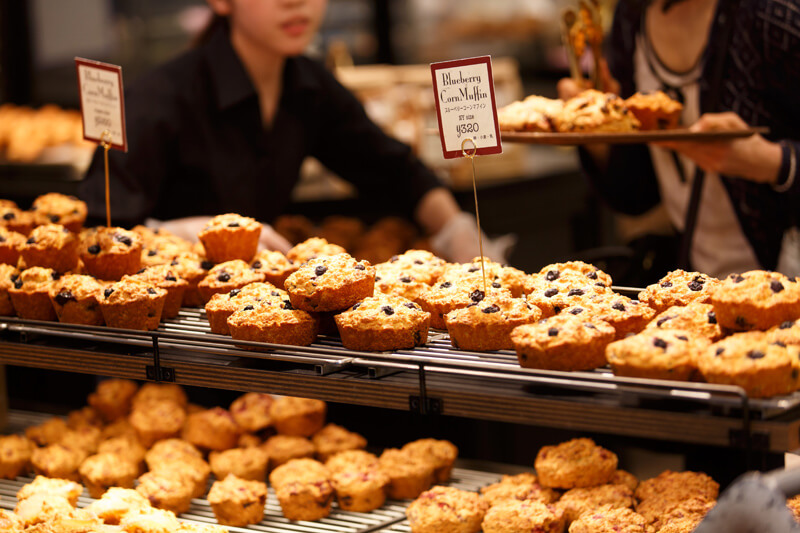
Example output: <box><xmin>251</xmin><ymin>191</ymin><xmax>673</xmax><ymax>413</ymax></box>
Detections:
<box><xmin>197</xmin><ymin>213</ymin><xmax>261</xmax><ymax>263</ymax></box>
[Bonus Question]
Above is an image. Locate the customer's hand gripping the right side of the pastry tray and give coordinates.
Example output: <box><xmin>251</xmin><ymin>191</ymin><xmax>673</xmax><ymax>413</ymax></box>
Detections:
<box><xmin>654</xmin><ymin>112</ymin><xmax>781</xmax><ymax>183</ymax></box>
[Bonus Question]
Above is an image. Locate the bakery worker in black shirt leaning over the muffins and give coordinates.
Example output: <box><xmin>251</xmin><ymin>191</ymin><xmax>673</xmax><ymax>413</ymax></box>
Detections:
<box><xmin>80</xmin><ymin>0</ymin><xmax>506</xmax><ymax>261</ymax></box>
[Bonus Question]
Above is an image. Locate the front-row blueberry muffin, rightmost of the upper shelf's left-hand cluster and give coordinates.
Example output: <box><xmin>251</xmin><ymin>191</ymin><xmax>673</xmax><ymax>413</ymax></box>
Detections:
<box><xmin>100</xmin><ymin>278</ymin><xmax>167</xmax><ymax>331</ymax></box>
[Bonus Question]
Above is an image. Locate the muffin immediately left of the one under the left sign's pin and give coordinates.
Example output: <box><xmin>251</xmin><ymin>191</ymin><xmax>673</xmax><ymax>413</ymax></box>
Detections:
<box><xmin>19</xmin><ymin>224</ymin><xmax>80</xmax><ymax>274</ymax></box>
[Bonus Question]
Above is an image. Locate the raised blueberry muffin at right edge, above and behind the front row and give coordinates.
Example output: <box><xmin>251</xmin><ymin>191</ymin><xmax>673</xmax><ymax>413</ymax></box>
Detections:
<box><xmin>711</xmin><ymin>270</ymin><xmax>800</xmax><ymax>331</ymax></box>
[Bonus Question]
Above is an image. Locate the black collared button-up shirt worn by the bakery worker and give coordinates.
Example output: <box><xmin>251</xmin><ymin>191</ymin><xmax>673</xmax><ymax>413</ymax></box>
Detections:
<box><xmin>80</xmin><ymin>28</ymin><xmax>440</xmax><ymax>225</ymax></box>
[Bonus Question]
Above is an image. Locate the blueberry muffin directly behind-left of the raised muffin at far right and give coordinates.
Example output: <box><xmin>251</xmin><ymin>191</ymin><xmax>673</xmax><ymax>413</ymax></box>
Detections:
<box><xmin>638</xmin><ymin>270</ymin><xmax>720</xmax><ymax>313</ymax></box>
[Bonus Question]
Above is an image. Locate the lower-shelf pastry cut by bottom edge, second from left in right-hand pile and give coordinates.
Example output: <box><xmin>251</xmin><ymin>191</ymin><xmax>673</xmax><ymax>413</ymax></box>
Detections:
<box><xmin>481</xmin><ymin>500</ymin><xmax>564</xmax><ymax>533</ymax></box>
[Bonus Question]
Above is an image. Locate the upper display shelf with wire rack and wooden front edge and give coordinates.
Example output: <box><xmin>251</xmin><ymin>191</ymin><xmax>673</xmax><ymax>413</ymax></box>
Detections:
<box><xmin>0</xmin><ymin>309</ymin><xmax>800</xmax><ymax>452</ymax></box>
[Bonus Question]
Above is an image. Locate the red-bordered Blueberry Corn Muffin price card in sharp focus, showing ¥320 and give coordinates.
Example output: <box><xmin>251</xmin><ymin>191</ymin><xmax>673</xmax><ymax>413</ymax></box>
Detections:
<box><xmin>431</xmin><ymin>56</ymin><xmax>503</xmax><ymax>159</ymax></box>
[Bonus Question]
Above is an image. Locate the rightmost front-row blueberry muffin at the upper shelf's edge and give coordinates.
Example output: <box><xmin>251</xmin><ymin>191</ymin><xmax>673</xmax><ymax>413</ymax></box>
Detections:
<box><xmin>697</xmin><ymin>331</ymin><xmax>800</xmax><ymax>398</ymax></box>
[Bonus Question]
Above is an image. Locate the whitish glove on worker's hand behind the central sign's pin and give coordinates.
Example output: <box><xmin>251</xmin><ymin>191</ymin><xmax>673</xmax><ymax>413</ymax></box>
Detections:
<box><xmin>431</xmin><ymin>211</ymin><xmax>517</xmax><ymax>264</ymax></box>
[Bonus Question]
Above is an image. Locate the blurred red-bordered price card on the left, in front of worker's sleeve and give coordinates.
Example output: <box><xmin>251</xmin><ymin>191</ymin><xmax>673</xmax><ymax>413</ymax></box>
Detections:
<box><xmin>75</xmin><ymin>57</ymin><xmax>128</xmax><ymax>152</ymax></box>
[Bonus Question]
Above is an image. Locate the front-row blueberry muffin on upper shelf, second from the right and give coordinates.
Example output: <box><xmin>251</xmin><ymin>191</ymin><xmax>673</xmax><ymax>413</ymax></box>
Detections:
<box><xmin>606</xmin><ymin>329</ymin><xmax>710</xmax><ymax>381</ymax></box>
